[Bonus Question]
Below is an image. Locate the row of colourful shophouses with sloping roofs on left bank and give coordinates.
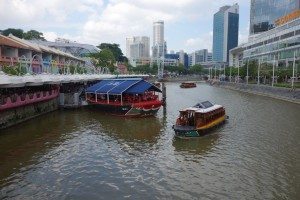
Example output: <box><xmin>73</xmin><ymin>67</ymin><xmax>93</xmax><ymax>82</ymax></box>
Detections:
<box><xmin>0</xmin><ymin>34</ymin><xmax>85</xmax><ymax>74</ymax></box>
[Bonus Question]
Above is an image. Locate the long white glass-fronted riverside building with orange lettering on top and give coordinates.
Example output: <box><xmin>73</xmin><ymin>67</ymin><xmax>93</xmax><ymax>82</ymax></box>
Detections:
<box><xmin>229</xmin><ymin>9</ymin><xmax>300</xmax><ymax>66</ymax></box>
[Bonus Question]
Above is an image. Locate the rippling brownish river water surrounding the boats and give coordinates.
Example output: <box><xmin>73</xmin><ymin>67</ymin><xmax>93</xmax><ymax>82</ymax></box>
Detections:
<box><xmin>0</xmin><ymin>83</ymin><xmax>300</xmax><ymax>199</ymax></box>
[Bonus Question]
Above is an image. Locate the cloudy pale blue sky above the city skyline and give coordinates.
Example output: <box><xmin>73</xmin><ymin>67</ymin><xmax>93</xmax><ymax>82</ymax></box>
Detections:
<box><xmin>0</xmin><ymin>0</ymin><xmax>250</xmax><ymax>54</ymax></box>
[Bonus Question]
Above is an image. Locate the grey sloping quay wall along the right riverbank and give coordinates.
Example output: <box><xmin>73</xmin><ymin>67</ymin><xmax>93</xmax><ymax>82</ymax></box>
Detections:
<box><xmin>209</xmin><ymin>81</ymin><xmax>300</xmax><ymax>104</ymax></box>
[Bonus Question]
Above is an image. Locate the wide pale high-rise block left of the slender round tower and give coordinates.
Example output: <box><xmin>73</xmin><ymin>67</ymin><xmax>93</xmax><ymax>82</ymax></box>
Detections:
<box><xmin>126</xmin><ymin>36</ymin><xmax>150</xmax><ymax>59</ymax></box>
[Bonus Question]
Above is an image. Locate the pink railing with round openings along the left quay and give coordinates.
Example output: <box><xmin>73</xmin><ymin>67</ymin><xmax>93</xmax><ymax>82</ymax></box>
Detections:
<box><xmin>0</xmin><ymin>89</ymin><xmax>59</xmax><ymax>111</ymax></box>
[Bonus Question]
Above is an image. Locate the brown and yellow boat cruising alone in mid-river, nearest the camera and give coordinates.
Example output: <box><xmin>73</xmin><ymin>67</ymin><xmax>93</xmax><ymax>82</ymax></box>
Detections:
<box><xmin>173</xmin><ymin>101</ymin><xmax>228</xmax><ymax>138</ymax></box>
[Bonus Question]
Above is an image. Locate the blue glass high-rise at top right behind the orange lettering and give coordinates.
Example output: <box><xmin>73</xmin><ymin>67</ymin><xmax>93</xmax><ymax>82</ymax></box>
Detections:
<box><xmin>250</xmin><ymin>0</ymin><xmax>300</xmax><ymax>35</ymax></box>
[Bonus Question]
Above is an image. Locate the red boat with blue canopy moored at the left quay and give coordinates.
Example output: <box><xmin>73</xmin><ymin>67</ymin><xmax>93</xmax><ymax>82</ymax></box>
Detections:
<box><xmin>85</xmin><ymin>78</ymin><xmax>162</xmax><ymax>117</ymax></box>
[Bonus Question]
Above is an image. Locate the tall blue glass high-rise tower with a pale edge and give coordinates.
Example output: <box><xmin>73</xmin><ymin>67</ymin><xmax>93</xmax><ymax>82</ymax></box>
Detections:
<box><xmin>213</xmin><ymin>4</ymin><xmax>239</xmax><ymax>62</ymax></box>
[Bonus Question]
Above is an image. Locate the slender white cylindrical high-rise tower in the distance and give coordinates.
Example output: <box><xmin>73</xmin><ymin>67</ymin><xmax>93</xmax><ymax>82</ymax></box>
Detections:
<box><xmin>152</xmin><ymin>21</ymin><xmax>167</xmax><ymax>58</ymax></box>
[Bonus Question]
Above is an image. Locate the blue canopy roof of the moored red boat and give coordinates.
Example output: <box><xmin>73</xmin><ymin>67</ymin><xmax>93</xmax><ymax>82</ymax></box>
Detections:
<box><xmin>86</xmin><ymin>78</ymin><xmax>161</xmax><ymax>95</ymax></box>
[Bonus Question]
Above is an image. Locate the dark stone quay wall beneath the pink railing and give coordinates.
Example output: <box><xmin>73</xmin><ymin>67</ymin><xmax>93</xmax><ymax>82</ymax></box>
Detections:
<box><xmin>0</xmin><ymin>98</ymin><xmax>59</xmax><ymax>129</ymax></box>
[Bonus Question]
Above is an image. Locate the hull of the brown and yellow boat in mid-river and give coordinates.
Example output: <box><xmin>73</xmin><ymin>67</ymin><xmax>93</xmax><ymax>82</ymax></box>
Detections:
<box><xmin>173</xmin><ymin>116</ymin><xmax>228</xmax><ymax>138</ymax></box>
